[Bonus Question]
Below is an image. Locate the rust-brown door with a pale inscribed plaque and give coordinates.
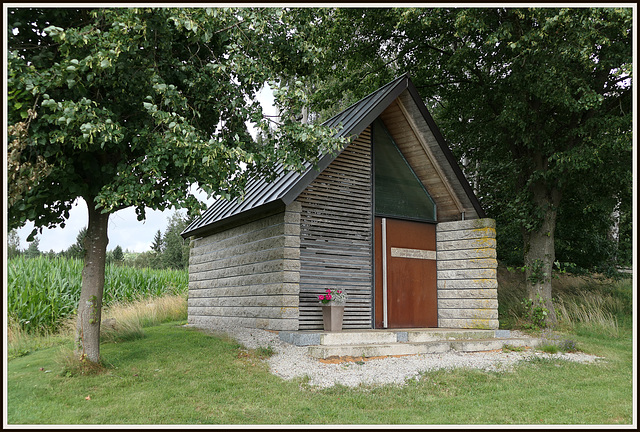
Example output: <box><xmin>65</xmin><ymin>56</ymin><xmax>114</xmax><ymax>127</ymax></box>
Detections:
<box><xmin>374</xmin><ymin>217</ymin><xmax>438</xmax><ymax>328</ymax></box>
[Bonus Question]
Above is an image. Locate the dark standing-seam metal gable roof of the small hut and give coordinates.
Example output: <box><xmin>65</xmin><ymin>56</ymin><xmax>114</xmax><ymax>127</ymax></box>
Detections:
<box><xmin>181</xmin><ymin>74</ymin><xmax>484</xmax><ymax>238</ymax></box>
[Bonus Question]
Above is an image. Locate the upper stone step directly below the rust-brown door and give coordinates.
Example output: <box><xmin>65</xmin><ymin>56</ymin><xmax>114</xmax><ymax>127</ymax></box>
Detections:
<box><xmin>279</xmin><ymin>329</ymin><xmax>510</xmax><ymax>346</ymax></box>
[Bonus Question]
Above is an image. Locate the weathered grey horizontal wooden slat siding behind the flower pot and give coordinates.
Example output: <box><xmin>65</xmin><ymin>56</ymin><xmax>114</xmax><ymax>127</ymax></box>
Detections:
<box><xmin>296</xmin><ymin>127</ymin><xmax>373</xmax><ymax>330</ymax></box>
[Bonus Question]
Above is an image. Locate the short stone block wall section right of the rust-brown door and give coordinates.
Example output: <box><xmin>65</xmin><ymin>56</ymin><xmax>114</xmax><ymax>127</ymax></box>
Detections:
<box><xmin>436</xmin><ymin>219</ymin><xmax>498</xmax><ymax>329</ymax></box>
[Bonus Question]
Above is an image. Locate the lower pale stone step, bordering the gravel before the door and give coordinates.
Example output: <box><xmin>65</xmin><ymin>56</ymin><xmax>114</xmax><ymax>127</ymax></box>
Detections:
<box><xmin>308</xmin><ymin>338</ymin><xmax>538</xmax><ymax>359</ymax></box>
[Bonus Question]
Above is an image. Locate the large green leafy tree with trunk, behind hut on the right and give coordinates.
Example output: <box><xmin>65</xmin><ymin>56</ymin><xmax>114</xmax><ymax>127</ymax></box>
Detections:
<box><xmin>299</xmin><ymin>8</ymin><xmax>632</xmax><ymax>322</ymax></box>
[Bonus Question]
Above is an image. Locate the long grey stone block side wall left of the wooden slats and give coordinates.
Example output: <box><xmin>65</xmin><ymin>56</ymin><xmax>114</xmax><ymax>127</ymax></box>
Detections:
<box><xmin>188</xmin><ymin>203</ymin><xmax>300</xmax><ymax>330</ymax></box>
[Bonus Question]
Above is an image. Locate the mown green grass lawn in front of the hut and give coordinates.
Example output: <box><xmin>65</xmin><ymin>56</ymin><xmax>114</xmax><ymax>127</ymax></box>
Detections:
<box><xmin>6</xmin><ymin>322</ymin><xmax>634</xmax><ymax>426</ymax></box>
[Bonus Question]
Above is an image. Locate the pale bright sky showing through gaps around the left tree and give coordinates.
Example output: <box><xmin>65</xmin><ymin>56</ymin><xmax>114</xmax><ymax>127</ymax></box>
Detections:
<box><xmin>5</xmin><ymin>85</ymin><xmax>276</xmax><ymax>252</ymax></box>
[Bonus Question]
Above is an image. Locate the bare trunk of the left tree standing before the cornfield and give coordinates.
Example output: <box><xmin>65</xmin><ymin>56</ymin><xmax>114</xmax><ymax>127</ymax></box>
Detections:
<box><xmin>76</xmin><ymin>199</ymin><xmax>109</xmax><ymax>363</ymax></box>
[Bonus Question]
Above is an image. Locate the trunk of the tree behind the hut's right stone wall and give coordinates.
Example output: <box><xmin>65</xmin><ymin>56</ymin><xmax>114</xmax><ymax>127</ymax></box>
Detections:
<box><xmin>523</xmin><ymin>184</ymin><xmax>560</xmax><ymax>324</ymax></box>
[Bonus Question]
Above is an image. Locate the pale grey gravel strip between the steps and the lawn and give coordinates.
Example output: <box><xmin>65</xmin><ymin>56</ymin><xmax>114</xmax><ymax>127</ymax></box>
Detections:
<box><xmin>198</xmin><ymin>327</ymin><xmax>601</xmax><ymax>387</ymax></box>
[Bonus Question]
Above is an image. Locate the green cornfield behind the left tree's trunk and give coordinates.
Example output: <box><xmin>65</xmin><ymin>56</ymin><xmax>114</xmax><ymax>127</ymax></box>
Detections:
<box><xmin>7</xmin><ymin>257</ymin><xmax>189</xmax><ymax>333</ymax></box>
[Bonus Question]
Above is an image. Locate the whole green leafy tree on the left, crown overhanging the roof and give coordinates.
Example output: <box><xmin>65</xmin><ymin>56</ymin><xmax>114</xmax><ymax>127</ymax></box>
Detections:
<box><xmin>7</xmin><ymin>8</ymin><xmax>342</xmax><ymax>362</ymax></box>
